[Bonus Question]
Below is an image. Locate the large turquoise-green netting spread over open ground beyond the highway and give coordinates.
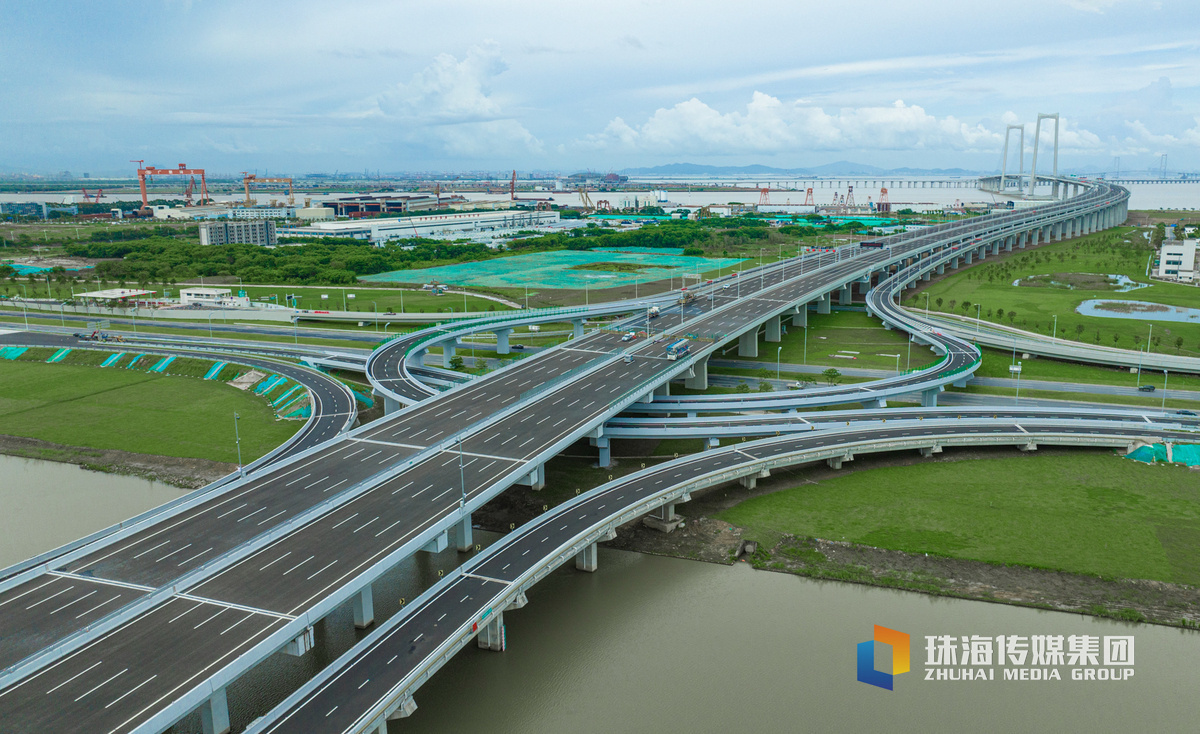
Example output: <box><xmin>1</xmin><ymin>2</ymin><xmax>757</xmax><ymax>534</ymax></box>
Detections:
<box><xmin>362</xmin><ymin>248</ymin><xmax>743</xmax><ymax>289</ymax></box>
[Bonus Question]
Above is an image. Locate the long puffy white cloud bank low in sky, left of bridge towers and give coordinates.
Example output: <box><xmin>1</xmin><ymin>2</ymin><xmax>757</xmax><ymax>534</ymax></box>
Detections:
<box><xmin>580</xmin><ymin>92</ymin><xmax>1003</xmax><ymax>155</ymax></box>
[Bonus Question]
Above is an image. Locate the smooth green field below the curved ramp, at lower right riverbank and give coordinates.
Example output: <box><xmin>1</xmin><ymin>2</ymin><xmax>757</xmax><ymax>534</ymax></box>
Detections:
<box><xmin>718</xmin><ymin>453</ymin><xmax>1200</xmax><ymax>584</ymax></box>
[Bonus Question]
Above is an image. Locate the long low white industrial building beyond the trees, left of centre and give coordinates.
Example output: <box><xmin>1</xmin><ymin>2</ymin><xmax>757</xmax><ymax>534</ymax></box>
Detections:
<box><xmin>280</xmin><ymin>210</ymin><xmax>559</xmax><ymax>245</ymax></box>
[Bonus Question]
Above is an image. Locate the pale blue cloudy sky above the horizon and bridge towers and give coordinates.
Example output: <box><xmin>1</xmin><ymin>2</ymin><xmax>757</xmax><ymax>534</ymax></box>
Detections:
<box><xmin>0</xmin><ymin>0</ymin><xmax>1200</xmax><ymax>176</ymax></box>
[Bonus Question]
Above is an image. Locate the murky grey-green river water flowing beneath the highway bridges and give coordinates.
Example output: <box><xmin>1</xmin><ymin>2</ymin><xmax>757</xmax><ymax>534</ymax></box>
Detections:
<box><xmin>0</xmin><ymin>457</ymin><xmax>1200</xmax><ymax>734</ymax></box>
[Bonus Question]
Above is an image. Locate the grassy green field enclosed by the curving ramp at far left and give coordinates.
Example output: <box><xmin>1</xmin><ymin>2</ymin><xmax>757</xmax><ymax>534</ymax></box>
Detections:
<box><xmin>0</xmin><ymin>361</ymin><xmax>296</xmax><ymax>463</ymax></box>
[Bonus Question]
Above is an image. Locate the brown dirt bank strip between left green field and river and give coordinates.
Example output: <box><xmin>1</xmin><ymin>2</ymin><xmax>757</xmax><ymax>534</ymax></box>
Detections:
<box><xmin>0</xmin><ymin>434</ymin><xmax>238</xmax><ymax>489</ymax></box>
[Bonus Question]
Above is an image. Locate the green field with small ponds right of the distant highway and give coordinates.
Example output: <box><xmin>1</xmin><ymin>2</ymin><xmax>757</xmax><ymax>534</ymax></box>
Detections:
<box><xmin>904</xmin><ymin>228</ymin><xmax>1200</xmax><ymax>356</ymax></box>
